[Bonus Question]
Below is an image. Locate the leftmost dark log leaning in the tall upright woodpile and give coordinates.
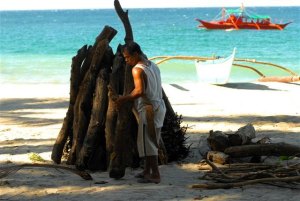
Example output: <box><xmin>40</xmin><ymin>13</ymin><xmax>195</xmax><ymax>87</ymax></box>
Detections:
<box><xmin>51</xmin><ymin>45</ymin><xmax>88</xmax><ymax>164</ymax></box>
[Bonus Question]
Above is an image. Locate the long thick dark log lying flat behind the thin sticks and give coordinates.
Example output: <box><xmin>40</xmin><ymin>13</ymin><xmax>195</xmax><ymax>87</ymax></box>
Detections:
<box><xmin>224</xmin><ymin>143</ymin><xmax>300</xmax><ymax>157</ymax></box>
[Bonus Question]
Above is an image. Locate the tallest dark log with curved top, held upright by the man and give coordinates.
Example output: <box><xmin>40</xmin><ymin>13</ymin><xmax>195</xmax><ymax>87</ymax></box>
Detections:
<box><xmin>106</xmin><ymin>0</ymin><xmax>141</xmax><ymax>179</ymax></box>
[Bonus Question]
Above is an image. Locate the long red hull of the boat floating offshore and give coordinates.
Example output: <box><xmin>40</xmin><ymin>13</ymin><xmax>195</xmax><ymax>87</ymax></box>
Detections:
<box><xmin>198</xmin><ymin>20</ymin><xmax>290</xmax><ymax>30</ymax></box>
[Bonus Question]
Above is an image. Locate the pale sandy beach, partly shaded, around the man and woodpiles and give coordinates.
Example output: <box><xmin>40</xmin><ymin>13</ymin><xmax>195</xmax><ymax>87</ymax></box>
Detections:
<box><xmin>0</xmin><ymin>82</ymin><xmax>300</xmax><ymax>201</ymax></box>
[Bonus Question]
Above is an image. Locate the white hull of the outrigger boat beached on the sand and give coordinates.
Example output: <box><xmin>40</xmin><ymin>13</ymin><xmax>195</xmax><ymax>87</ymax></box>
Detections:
<box><xmin>195</xmin><ymin>48</ymin><xmax>236</xmax><ymax>84</ymax></box>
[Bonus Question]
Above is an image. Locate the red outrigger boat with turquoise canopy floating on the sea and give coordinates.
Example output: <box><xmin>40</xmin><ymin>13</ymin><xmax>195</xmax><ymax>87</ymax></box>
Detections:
<box><xmin>196</xmin><ymin>6</ymin><xmax>291</xmax><ymax>30</ymax></box>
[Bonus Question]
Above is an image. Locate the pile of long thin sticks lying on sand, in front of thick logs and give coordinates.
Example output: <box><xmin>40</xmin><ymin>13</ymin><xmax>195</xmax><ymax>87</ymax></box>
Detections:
<box><xmin>191</xmin><ymin>159</ymin><xmax>300</xmax><ymax>189</ymax></box>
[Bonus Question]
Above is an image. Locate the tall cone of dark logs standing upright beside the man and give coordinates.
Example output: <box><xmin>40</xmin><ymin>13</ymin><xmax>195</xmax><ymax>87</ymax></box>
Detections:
<box><xmin>51</xmin><ymin>0</ymin><xmax>189</xmax><ymax>178</ymax></box>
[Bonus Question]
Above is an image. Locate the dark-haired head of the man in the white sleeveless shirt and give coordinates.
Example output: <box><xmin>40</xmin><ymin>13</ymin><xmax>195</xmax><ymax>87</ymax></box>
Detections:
<box><xmin>123</xmin><ymin>42</ymin><xmax>143</xmax><ymax>66</ymax></box>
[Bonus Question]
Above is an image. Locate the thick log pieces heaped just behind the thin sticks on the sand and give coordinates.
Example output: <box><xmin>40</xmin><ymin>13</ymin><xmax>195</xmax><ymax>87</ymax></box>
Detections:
<box><xmin>206</xmin><ymin>124</ymin><xmax>300</xmax><ymax>164</ymax></box>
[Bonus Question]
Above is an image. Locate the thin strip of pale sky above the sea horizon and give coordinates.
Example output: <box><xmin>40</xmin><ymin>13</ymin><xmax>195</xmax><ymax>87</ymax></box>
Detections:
<box><xmin>0</xmin><ymin>0</ymin><xmax>300</xmax><ymax>10</ymax></box>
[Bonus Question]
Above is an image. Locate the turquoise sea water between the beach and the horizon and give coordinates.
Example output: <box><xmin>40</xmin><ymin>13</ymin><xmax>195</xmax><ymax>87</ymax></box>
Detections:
<box><xmin>0</xmin><ymin>7</ymin><xmax>300</xmax><ymax>84</ymax></box>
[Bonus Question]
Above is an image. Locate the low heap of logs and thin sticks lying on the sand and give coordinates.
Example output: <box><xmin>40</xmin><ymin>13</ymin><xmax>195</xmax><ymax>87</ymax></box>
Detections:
<box><xmin>192</xmin><ymin>124</ymin><xmax>300</xmax><ymax>189</ymax></box>
